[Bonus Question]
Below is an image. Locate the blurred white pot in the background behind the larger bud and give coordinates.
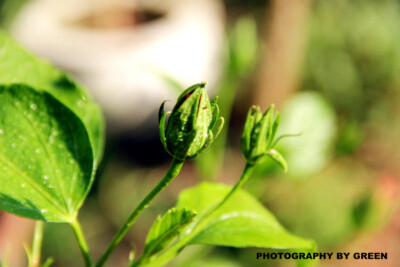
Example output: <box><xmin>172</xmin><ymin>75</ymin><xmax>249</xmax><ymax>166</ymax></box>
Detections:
<box><xmin>12</xmin><ymin>0</ymin><xmax>224</xmax><ymax>131</ymax></box>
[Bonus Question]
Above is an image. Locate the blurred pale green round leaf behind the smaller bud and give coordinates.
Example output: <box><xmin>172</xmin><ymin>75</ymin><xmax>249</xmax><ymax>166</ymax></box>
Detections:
<box><xmin>278</xmin><ymin>92</ymin><xmax>336</xmax><ymax>177</ymax></box>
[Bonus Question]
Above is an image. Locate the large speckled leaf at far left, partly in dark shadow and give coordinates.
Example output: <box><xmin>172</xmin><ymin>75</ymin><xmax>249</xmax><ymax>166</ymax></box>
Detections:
<box><xmin>0</xmin><ymin>85</ymin><xmax>93</xmax><ymax>222</ymax></box>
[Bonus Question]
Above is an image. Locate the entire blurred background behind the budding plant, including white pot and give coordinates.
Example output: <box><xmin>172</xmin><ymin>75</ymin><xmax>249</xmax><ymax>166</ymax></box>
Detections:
<box><xmin>0</xmin><ymin>0</ymin><xmax>400</xmax><ymax>267</ymax></box>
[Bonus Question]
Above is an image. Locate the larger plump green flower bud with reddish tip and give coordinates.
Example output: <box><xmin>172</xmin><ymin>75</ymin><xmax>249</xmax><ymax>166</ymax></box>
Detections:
<box><xmin>159</xmin><ymin>83</ymin><xmax>224</xmax><ymax>161</ymax></box>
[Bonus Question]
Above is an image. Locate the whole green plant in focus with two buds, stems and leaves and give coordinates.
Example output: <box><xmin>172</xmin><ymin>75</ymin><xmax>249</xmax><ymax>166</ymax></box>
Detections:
<box><xmin>0</xmin><ymin>33</ymin><xmax>315</xmax><ymax>266</ymax></box>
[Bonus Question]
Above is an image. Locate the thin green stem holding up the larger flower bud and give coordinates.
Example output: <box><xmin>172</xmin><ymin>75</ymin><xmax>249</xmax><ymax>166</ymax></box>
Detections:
<box><xmin>96</xmin><ymin>158</ymin><xmax>184</xmax><ymax>267</ymax></box>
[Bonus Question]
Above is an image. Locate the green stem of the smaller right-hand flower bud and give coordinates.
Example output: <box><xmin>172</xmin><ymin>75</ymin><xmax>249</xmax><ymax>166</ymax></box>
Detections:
<box><xmin>133</xmin><ymin>163</ymin><xmax>255</xmax><ymax>267</ymax></box>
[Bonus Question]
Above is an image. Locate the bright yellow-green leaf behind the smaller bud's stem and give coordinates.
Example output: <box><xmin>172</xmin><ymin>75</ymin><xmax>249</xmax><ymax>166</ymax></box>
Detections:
<box><xmin>177</xmin><ymin>183</ymin><xmax>315</xmax><ymax>250</ymax></box>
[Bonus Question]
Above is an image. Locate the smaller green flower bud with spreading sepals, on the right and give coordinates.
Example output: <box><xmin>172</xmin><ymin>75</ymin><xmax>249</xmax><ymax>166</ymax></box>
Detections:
<box><xmin>242</xmin><ymin>105</ymin><xmax>287</xmax><ymax>171</ymax></box>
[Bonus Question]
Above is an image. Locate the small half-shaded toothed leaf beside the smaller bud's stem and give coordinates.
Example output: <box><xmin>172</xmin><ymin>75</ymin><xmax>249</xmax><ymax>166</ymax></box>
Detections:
<box><xmin>144</xmin><ymin>208</ymin><xmax>196</xmax><ymax>256</ymax></box>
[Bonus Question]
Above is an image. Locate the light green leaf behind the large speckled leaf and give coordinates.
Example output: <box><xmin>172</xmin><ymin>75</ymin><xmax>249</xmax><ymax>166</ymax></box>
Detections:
<box><xmin>0</xmin><ymin>31</ymin><xmax>104</xmax><ymax>165</ymax></box>
